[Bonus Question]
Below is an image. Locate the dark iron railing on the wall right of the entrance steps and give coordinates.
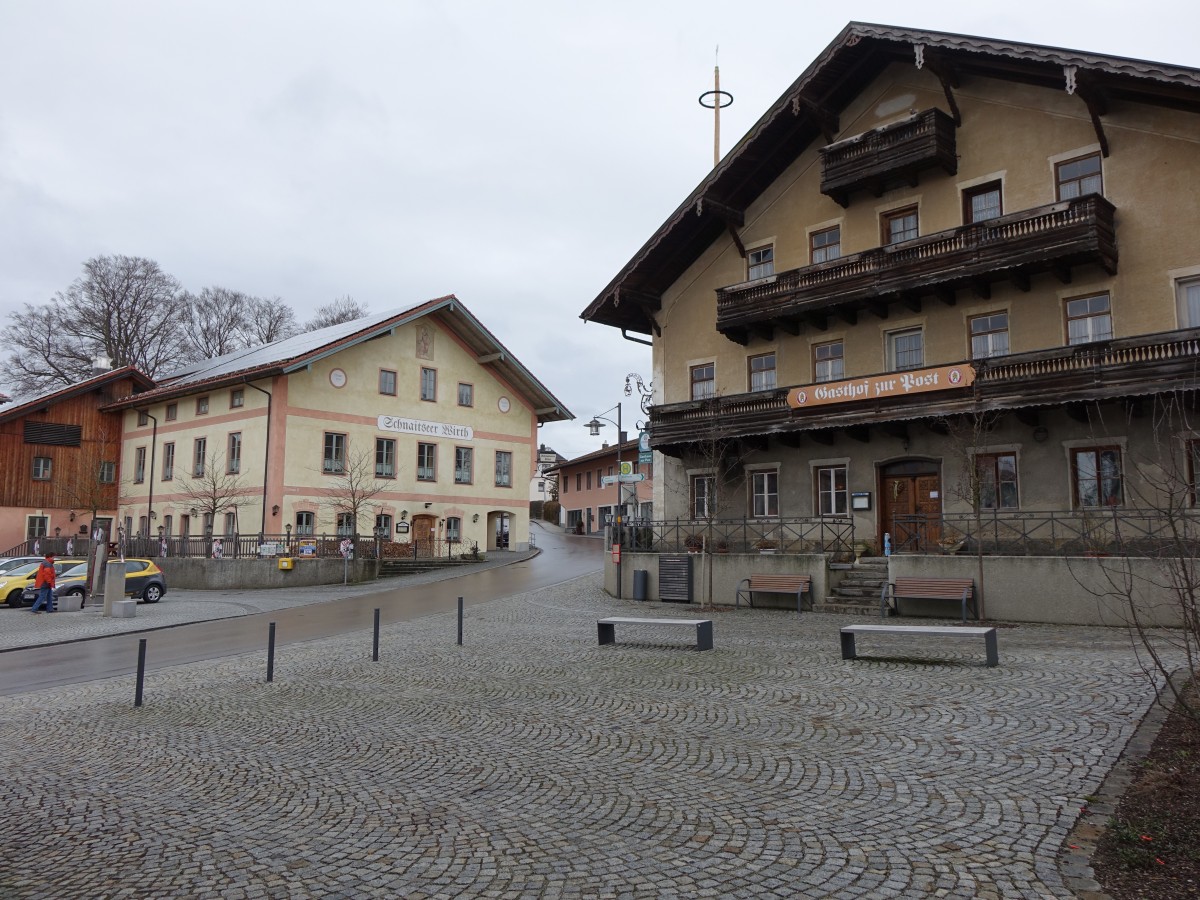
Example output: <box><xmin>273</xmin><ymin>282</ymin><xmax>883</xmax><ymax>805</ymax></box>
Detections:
<box><xmin>892</xmin><ymin>506</ymin><xmax>1200</xmax><ymax>557</ymax></box>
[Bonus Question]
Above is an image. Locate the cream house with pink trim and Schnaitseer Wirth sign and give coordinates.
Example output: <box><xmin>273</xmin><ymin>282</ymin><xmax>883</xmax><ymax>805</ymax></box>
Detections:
<box><xmin>110</xmin><ymin>295</ymin><xmax>572</xmax><ymax>556</ymax></box>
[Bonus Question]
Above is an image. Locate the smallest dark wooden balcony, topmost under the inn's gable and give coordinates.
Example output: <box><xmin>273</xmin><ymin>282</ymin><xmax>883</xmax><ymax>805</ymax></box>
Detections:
<box><xmin>821</xmin><ymin>109</ymin><xmax>959</xmax><ymax>206</ymax></box>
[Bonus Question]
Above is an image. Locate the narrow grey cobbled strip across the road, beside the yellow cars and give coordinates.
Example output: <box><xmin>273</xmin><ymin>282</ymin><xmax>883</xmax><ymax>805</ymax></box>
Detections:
<box><xmin>0</xmin><ymin>551</ymin><xmax>536</xmax><ymax>650</ymax></box>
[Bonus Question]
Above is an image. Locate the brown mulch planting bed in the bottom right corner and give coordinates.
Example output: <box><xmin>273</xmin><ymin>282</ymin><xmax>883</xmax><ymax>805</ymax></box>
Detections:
<box><xmin>1092</xmin><ymin>682</ymin><xmax>1200</xmax><ymax>900</ymax></box>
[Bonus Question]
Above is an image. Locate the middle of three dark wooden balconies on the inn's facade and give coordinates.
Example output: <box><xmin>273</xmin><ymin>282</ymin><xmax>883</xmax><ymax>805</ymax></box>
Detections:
<box><xmin>716</xmin><ymin>194</ymin><xmax>1117</xmax><ymax>344</ymax></box>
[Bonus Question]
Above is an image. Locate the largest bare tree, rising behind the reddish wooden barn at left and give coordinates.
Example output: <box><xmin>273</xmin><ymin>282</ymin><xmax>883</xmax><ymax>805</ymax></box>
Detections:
<box><xmin>8</xmin><ymin>256</ymin><xmax>184</xmax><ymax>394</ymax></box>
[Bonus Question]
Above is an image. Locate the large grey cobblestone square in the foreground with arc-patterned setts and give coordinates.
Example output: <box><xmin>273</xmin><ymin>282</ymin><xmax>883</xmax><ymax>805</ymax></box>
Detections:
<box><xmin>0</xmin><ymin>576</ymin><xmax>1152</xmax><ymax>899</ymax></box>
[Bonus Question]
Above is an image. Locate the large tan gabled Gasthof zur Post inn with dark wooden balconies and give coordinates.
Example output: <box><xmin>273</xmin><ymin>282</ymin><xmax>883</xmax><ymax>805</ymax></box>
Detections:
<box><xmin>582</xmin><ymin>23</ymin><xmax>1200</xmax><ymax>624</ymax></box>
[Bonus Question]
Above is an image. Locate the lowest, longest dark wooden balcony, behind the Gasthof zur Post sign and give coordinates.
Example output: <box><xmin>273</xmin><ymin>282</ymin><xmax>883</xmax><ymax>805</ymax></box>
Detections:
<box><xmin>649</xmin><ymin>329</ymin><xmax>1200</xmax><ymax>455</ymax></box>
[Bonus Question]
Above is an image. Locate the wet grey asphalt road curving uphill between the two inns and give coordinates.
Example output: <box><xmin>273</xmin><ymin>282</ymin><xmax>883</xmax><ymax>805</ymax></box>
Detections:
<box><xmin>0</xmin><ymin>529</ymin><xmax>602</xmax><ymax>695</ymax></box>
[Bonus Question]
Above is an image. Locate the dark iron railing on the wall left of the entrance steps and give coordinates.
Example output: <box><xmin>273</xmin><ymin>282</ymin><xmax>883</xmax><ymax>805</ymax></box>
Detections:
<box><xmin>618</xmin><ymin>516</ymin><xmax>854</xmax><ymax>559</ymax></box>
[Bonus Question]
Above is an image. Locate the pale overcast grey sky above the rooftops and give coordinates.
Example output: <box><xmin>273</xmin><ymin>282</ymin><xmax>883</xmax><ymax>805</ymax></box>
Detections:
<box><xmin>0</xmin><ymin>0</ymin><xmax>1200</xmax><ymax>457</ymax></box>
